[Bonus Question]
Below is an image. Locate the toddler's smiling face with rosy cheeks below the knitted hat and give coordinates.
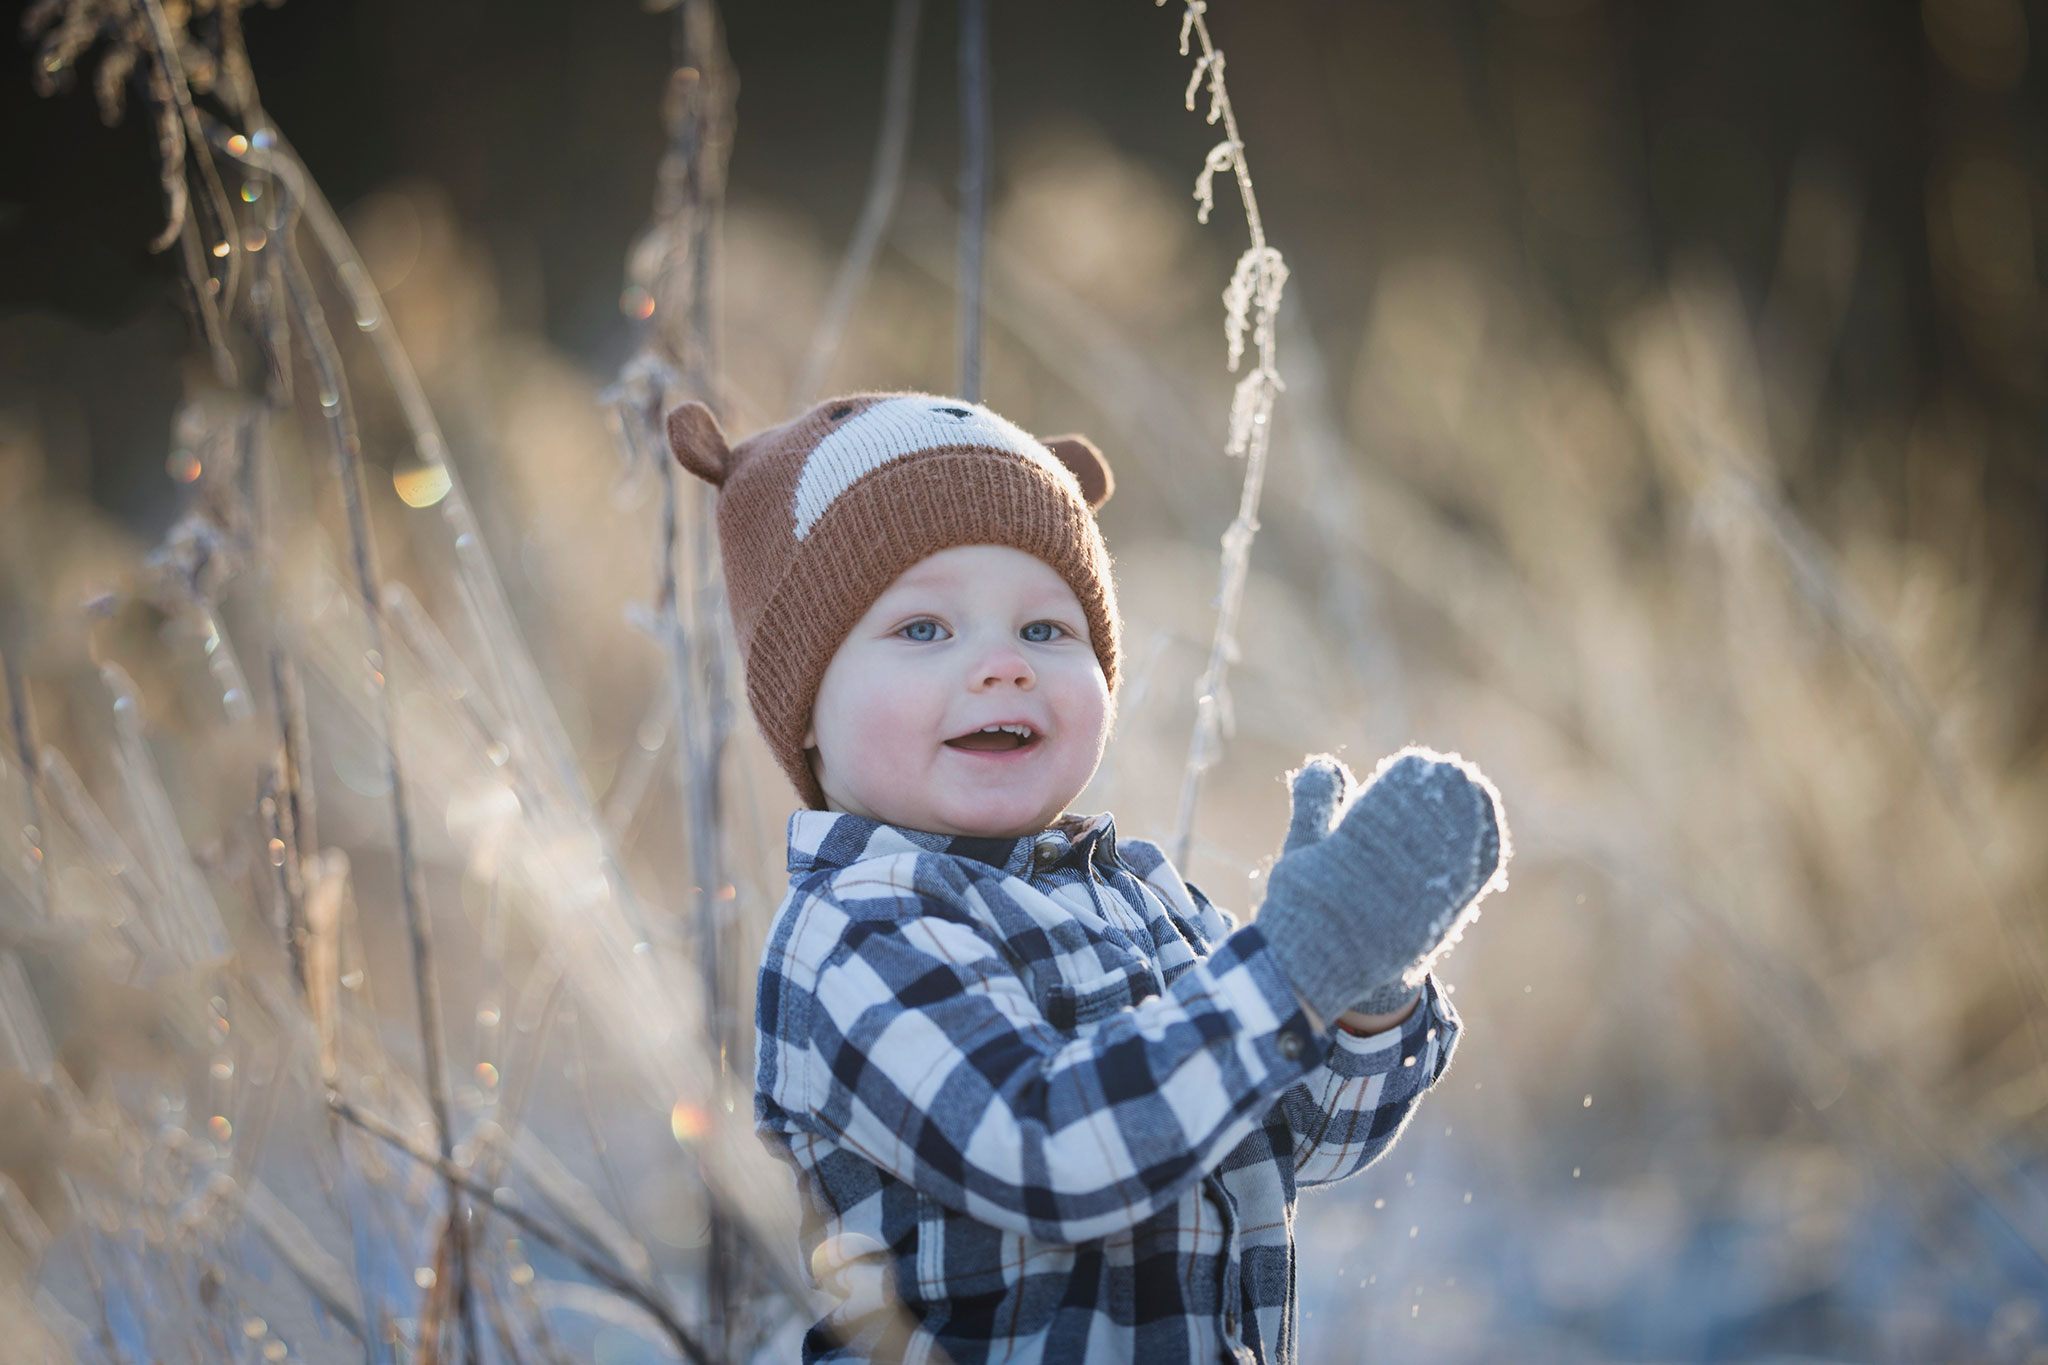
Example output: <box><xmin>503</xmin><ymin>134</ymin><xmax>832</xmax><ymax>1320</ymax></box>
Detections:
<box><xmin>803</xmin><ymin>544</ymin><xmax>1110</xmax><ymax>837</ymax></box>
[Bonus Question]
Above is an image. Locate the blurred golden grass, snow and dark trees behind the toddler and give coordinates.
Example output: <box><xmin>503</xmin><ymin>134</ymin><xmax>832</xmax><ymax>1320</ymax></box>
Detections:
<box><xmin>0</xmin><ymin>0</ymin><xmax>2048</xmax><ymax>1363</ymax></box>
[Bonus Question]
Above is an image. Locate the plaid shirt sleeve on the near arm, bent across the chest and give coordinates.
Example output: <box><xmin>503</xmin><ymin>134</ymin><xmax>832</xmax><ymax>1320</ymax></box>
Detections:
<box><xmin>770</xmin><ymin>855</ymin><xmax>1321</xmax><ymax>1242</ymax></box>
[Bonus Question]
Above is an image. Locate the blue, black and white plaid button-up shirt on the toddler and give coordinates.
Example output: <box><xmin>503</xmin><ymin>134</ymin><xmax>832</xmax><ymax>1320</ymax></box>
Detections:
<box><xmin>754</xmin><ymin>810</ymin><xmax>1458</xmax><ymax>1365</ymax></box>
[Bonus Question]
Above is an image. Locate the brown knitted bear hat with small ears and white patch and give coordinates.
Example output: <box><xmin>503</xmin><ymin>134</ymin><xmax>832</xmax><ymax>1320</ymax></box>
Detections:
<box><xmin>668</xmin><ymin>393</ymin><xmax>1120</xmax><ymax>808</ymax></box>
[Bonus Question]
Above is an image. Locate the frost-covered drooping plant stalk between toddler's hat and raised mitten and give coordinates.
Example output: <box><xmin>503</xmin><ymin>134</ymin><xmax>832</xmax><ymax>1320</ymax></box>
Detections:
<box><xmin>1155</xmin><ymin>0</ymin><xmax>1286</xmax><ymax>868</ymax></box>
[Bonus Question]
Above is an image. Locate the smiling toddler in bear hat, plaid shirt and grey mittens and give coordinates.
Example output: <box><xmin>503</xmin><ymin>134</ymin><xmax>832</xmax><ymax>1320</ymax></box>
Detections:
<box><xmin>668</xmin><ymin>393</ymin><xmax>1507</xmax><ymax>1365</ymax></box>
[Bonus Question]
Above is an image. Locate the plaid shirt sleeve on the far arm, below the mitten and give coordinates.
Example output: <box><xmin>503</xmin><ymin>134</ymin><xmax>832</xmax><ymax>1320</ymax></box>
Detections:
<box><xmin>1278</xmin><ymin>976</ymin><xmax>1460</xmax><ymax>1185</ymax></box>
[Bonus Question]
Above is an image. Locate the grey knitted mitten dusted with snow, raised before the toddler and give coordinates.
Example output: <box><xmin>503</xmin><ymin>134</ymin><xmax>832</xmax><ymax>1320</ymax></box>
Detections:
<box><xmin>1257</xmin><ymin>747</ymin><xmax>1509</xmax><ymax>1023</ymax></box>
